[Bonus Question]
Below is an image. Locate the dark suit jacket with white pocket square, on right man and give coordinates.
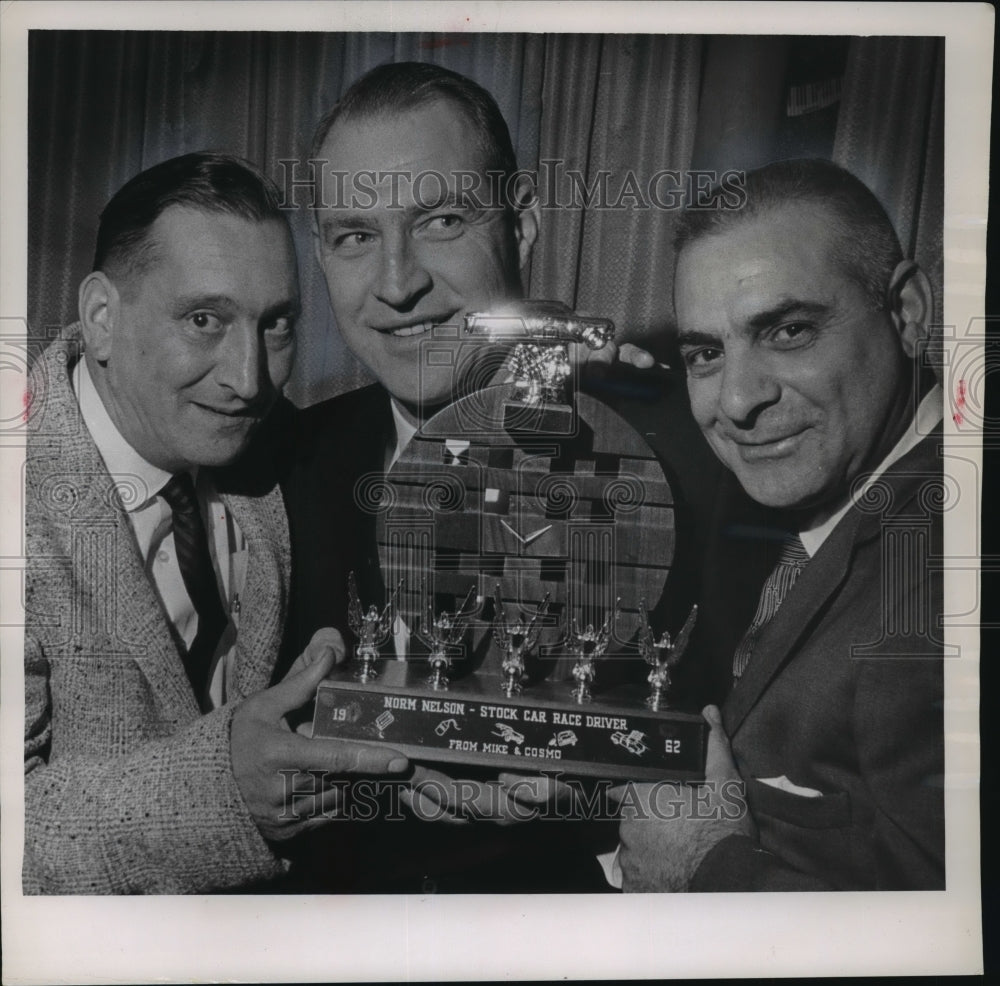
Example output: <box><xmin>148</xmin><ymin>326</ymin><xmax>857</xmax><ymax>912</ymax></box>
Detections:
<box><xmin>692</xmin><ymin>429</ymin><xmax>944</xmax><ymax>890</ymax></box>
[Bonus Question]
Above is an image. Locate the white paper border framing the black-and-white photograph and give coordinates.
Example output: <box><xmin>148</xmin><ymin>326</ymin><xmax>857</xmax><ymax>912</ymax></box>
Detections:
<box><xmin>0</xmin><ymin>0</ymin><xmax>994</xmax><ymax>983</ymax></box>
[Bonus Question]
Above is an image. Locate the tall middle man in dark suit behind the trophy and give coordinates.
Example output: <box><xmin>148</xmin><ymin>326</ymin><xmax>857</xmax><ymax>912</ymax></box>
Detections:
<box><xmin>283</xmin><ymin>63</ymin><xmax>711</xmax><ymax>890</ymax></box>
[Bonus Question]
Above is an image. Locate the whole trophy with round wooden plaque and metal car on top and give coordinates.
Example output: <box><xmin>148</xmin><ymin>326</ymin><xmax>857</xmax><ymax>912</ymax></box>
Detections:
<box><xmin>313</xmin><ymin>302</ymin><xmax>708</xmax><ymax>780</ymax></box>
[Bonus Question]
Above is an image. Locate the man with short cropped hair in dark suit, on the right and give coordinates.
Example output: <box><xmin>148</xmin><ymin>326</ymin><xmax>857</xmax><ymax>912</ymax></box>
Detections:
<box><xmin>619</xmin><ymin>161</ymin><xmax>944</xmax><ymax>891</ymax></box>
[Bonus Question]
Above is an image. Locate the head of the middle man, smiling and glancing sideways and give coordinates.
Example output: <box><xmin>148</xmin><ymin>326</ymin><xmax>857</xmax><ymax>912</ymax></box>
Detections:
<box><xmin>315</xmin><ymin>88</ymin><xmax>538</xmax><ymax>416</ymax></box>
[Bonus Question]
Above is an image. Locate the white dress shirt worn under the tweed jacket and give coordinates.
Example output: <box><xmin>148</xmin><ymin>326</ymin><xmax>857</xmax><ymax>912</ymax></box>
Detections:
<box><xmin>72</xmin><ymin>359</ymin><xmax>247</xmax><ymax>708</ymax></box>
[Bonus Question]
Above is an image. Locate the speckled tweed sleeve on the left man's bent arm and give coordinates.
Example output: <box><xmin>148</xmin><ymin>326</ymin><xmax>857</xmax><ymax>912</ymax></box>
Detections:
<box><xmin>22</xmin><ymin>635</ymin><xmax>286</xmax><ymax>894</ymax></box>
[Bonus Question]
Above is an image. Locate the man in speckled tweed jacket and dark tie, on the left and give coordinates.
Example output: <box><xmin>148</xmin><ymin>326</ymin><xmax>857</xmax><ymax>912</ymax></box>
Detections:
<box><xmin>23</xmin><ymin>154</ymin><xmax>406</xmax><ymax>894</ymax></box>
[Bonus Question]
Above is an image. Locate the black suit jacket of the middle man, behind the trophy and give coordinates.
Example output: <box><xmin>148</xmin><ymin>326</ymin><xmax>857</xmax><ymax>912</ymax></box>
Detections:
<box><xmin>278</xmin><ymin>373</ymin><xmax>721</xmax><ymax>892</ymax></box>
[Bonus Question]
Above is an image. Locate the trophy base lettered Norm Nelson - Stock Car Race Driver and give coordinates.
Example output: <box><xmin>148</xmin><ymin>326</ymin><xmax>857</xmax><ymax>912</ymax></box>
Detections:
<box><xmin>313</xmin><ymin>661</ymin><xmax>708</xmax><ymax>781</ymax></box>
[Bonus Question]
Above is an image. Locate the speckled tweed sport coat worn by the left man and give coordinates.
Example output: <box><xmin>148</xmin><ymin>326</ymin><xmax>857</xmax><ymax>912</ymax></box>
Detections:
<box><xmin>22</xmin><ymin>326</ymin><xmax>289</xmax><ymax>894</ymax></box>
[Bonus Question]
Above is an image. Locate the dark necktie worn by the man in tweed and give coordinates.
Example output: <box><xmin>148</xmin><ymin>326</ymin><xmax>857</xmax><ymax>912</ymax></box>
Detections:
<box><xmin>160</xmin><ymin>472</ymin><xmax>229</xmax><ymax>704</ymax></box>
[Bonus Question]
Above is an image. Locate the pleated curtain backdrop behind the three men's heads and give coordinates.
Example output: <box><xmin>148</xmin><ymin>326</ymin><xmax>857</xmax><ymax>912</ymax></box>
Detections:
<box><xmin>28</xmin><ymin>31</ymin><xmax>944</xmax><ymax>405</ymax></box>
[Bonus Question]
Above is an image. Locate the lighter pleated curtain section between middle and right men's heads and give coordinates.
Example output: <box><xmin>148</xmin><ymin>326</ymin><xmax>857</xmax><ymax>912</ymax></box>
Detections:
<box><xmin>530</xmin><ymin>35</ymin><xmax>702</xmax><ymax>342</ymax></box>
